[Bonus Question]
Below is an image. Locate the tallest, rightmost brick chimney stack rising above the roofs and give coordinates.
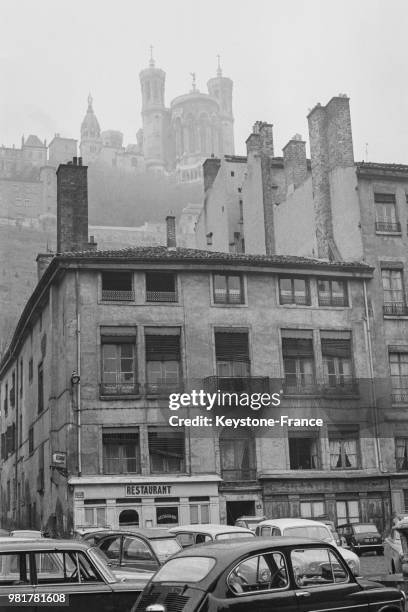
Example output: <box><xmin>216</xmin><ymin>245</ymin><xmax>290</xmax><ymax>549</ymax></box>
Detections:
<box><xmin>308</xmin><ymin>94</ymin><xmax>354</xmax><ymax>258</ymax></box>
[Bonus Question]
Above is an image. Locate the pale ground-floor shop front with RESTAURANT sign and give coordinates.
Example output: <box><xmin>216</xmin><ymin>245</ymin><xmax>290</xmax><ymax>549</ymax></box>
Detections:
<box><xmin>68</xmin><ymin>475</ymin><xmax>220</xmax><ymax>529</ymax></box>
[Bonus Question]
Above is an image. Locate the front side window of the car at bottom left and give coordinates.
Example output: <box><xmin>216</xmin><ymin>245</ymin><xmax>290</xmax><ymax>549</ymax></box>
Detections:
<box><xmin>35</xmin><ymin>551</ymin><xmax>101</xmax><ymax>584</ymax></box>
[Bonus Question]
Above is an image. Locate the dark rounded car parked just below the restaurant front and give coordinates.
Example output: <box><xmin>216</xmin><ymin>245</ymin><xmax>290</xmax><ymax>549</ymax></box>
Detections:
<box><xmin>83</xmin><ymin>529</ymin><xmax>181</xmax><ymax>572</ymax></box>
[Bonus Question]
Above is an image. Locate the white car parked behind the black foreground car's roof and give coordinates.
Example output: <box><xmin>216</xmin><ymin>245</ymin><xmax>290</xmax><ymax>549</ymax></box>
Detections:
<box><xmin>255</xmin><ymin>518</ymin><xmax>360</xmax><ymax>576</ymax></box>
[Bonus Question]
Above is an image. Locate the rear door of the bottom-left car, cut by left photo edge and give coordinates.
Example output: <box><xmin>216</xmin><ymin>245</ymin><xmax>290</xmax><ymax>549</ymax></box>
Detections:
<box><xmin>0</xmin><ymin>552</ymin><xmax>36</xmax><ymax>612</ymax></box>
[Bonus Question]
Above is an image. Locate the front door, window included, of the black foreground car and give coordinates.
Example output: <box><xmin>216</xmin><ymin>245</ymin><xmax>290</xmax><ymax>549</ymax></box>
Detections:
<box><xmin>290</xmin><ymin>546</ymin><xmax>368</xmax><ymax>612</ymax></box>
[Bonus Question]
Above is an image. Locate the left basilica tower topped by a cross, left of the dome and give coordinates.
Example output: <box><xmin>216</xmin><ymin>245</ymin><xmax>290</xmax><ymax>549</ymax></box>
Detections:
<box><xmin>139</xmin><ymin>48</ymin><xmax>169</xmax><ymax>170</ymax></box>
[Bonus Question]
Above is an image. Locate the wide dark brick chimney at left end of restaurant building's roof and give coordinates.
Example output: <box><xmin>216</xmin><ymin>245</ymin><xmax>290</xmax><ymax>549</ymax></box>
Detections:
<box><xmin>57</xmin><ymin>157</ymin><xmax>88</xmax><ymax>253</ymax></box>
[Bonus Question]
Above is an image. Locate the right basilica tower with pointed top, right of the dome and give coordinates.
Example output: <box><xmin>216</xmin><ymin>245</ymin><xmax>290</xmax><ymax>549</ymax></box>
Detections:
<box><xmin>207</xmin><ymin>56</ymin><xmax>235</xmax><ymax>155</ymax></box>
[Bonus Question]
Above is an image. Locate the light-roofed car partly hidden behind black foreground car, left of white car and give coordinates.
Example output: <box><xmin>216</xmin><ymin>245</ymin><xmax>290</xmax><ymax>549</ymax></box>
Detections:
<box><xmin>169</xmin><ymin>524</ymin><xmax>255</xmax><ymax>548</ymax></box>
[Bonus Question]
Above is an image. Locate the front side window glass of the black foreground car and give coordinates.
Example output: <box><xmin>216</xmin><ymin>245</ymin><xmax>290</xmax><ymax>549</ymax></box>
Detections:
<box><xmin>291</xmin><ymin>548</ymin><xmax>349</xmax><ymax>587</ymax></box>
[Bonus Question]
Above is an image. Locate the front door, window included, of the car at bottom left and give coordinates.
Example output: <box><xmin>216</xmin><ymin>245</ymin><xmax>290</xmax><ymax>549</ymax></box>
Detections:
<box><xmin>32</xmin><ymin>549</ymin><xmax>115</xmax><ymax>612</ymax></box>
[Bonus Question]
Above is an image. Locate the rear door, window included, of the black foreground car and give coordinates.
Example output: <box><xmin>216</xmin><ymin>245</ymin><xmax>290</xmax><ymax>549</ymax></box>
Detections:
<box><xmin>217</xmin><ymin>551</ymin><xmax>297</xmax><ymax>612</ymax></box>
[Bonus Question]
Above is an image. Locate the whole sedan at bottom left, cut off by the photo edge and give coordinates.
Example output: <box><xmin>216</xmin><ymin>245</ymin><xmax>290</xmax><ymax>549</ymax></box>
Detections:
<box><xmin>0</xmin><ymin>537</ymin><xmax>147</xmax><ymax>612</ymax></box>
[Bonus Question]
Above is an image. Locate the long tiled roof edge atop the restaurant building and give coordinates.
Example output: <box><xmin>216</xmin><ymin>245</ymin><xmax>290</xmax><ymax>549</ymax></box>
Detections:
<box><xmin>58</xmin><ymin>246</ymin><xmax>370</xmax><ymax>270</ymax></box>
